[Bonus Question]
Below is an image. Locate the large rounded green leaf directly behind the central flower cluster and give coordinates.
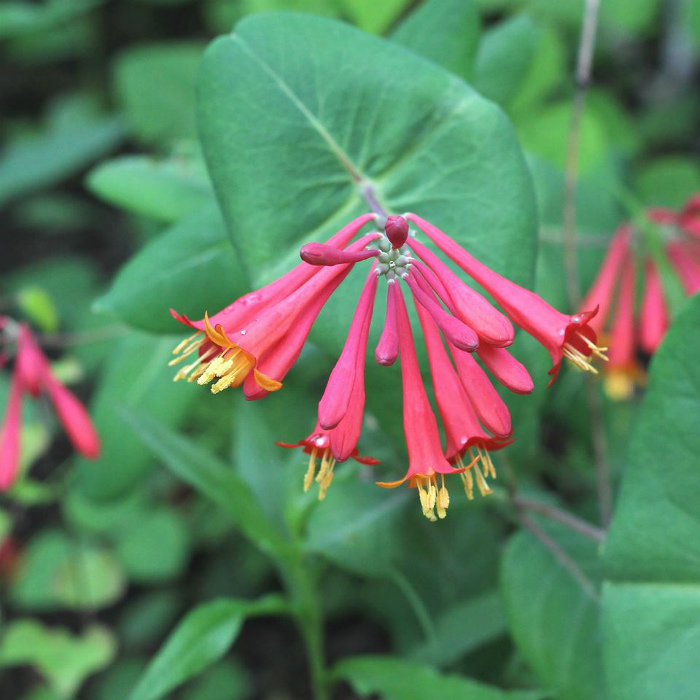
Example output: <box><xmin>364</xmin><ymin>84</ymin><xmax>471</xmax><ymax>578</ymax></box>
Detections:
<box><xmin>198</xmin><ymin>14</ymin><xmax>536</xmax><ymax>351</ymax></box>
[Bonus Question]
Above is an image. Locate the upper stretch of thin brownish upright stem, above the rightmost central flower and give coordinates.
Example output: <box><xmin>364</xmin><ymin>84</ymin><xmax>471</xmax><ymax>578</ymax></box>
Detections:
<box><xmin>563</xmin><ymin>0</ymin><xmax>600</xmax><ymax>311</ymax></box>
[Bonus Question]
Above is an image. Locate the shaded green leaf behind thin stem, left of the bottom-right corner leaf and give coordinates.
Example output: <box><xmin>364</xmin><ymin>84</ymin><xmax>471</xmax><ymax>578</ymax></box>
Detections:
<box><xmin>501</xmin><ymin>527</ymin><xmax>604</xmax><ymax>700</ymax></box>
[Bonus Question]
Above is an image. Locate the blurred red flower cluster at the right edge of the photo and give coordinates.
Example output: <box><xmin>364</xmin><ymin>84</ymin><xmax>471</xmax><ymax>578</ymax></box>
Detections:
<box><xmin>582</xmin><ymin>195</ymin><xmax>700</xmax><ymax>399</ymax></box>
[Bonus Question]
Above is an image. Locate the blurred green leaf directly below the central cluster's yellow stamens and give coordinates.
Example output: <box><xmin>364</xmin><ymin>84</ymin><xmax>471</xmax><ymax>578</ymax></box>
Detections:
<box><xmin>306</xmin><ymin>478</ymin><xmax>408</xmax><ymax>576</ymax></box>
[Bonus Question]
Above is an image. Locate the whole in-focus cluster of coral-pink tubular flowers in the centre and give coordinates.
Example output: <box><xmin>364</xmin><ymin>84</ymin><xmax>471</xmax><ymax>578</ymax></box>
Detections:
<box><xmin>171</xmin><ymin>213</ymin><xmax>603</xmax><ymax>520</ymax></box>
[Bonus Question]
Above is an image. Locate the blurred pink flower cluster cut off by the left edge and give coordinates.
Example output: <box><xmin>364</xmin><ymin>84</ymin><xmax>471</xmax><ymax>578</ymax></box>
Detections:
<box><xmin>0</xmin><ymin>316</ymin><xmax>100</xmax><ymax>491</ymax></box>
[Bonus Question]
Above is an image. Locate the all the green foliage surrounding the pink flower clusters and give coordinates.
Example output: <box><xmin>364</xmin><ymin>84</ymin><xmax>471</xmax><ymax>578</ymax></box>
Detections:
<box><xmin>0</xmin><ymin>0</ymin><xmax>700</xmax><ymax>700</ymax></box>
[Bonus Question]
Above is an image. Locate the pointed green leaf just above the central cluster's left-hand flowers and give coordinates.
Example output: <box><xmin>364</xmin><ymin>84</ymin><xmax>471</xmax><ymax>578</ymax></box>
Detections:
<box><xmin>93</xmin><ymin>206</ymin><xmax>248</xmax><ymax>334</ymax></box>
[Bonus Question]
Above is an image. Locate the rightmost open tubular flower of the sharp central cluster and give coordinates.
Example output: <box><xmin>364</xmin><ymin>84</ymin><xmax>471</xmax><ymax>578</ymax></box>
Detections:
<box><xmin>406</xmin><ymin>214</ymin><xmax>604</xmax><ymax>381</ymax></box>
